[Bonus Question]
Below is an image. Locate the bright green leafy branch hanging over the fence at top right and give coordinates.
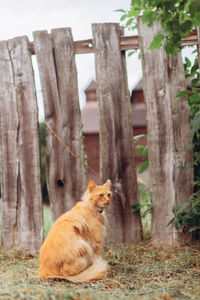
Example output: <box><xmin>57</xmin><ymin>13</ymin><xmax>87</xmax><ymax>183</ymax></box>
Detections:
<box><xmin>118</xmin><ymin>0</ymin><xmax>200</xmax><ymax>56</ymax></box>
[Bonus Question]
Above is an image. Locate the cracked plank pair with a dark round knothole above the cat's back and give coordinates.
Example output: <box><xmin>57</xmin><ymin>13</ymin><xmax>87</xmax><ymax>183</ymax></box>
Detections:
<box><xmin>34</xmin><ymin>28</ymin><xmax>85</xmax><ymax>219</ymax></box>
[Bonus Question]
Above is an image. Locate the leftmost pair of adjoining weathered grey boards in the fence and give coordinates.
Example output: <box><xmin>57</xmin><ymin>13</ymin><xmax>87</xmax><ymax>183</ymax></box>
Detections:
<box><xmin>0</xmin><ymin>37</ymin><xmax>43</xmax><ymax>254</ymax></box>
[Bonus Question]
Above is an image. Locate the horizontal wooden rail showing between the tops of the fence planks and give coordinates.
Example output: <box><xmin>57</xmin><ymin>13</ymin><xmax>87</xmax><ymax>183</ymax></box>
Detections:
<box><xmin>30</xmin><ymin>29</ymin><xmax>198</xmax><ymax>55</ymax></box>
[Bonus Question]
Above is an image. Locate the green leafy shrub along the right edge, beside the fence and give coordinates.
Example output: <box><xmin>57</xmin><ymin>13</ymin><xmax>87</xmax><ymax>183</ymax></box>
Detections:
<box><xmin>173</xmin><ymin>54</ymin><xmax>200</xmax><ymax>234</ymax></box>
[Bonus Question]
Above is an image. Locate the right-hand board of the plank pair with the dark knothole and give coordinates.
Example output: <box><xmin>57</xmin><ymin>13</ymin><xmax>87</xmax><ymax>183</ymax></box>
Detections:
<box><xmin>52</xmin><ymin>28</ymin><xmax>86</xmax><ymax>210</ymax></box>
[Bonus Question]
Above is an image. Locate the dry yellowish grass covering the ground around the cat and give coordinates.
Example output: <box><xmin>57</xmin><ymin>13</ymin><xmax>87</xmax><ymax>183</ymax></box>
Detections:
<box><xmin>0</xmin><ymin>242</ymin><xmax>200</xmax><ymax>300</ymax></box>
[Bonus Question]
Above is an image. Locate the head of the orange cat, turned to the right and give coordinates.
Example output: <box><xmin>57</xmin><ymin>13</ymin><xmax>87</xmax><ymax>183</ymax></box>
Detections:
<box><xmin>83</xmin><ymin>179</ymin><xmax>112</xmax><ymax>213</ymax></box>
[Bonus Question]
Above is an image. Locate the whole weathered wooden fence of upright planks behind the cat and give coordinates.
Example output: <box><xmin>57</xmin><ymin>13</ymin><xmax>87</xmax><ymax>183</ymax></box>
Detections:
<box><xmin>0</xmin><ymin>24</ymin><xmax>200</xmax><ymax>254</ymax></box>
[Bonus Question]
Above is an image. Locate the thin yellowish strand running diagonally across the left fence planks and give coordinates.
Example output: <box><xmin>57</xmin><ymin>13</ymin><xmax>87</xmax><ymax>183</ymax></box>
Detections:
<box><xmin>21</xmin><ymin>87</ymin><xmax>99</xmax><ymax>176</ymax></box>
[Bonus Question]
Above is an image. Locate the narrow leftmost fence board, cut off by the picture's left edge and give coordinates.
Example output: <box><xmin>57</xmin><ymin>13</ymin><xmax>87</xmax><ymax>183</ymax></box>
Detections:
<box><xmin>0</xmin><ymin>41</ymin><xmax>19</xmax><ymax>248</ymax></box>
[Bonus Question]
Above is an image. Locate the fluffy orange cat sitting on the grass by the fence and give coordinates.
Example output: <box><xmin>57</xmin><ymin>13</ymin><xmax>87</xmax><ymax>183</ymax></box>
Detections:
<box><xmin>39</xmin><ymin>180</ymin><xmax>112</xmax><ymax>282</ymax></box>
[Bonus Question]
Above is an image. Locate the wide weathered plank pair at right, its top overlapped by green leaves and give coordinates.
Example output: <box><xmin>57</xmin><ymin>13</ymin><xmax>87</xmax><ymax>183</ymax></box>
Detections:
<box><xmin>138</xmin><ymin>19</ymin><xmax>193</xmax><ymax>245</ymax></box>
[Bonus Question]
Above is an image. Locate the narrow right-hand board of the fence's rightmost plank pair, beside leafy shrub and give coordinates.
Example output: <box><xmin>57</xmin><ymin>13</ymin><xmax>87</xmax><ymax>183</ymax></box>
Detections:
<box><xmin>167</xmin><ymin>53</ymin><xmax>194</xmax><ymax>212</ymax></box>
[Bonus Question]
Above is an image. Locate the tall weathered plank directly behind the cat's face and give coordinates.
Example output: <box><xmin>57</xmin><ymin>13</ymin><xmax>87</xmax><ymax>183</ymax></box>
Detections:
<box><xmin>92</xmin><ymin>24</ymin><xmax>142</xmax><ymax>243</ymax></box>
